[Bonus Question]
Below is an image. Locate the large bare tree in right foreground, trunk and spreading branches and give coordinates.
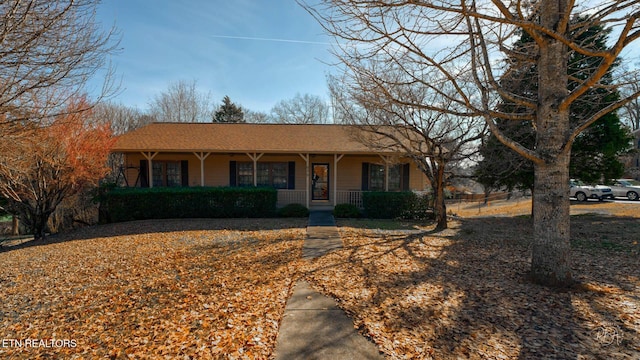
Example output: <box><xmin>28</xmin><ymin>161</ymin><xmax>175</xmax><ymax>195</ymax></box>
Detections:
<box><xmin>302</xmin><ymin>0</ymin><xmax>640</xmax><ymax>286</ymax></box>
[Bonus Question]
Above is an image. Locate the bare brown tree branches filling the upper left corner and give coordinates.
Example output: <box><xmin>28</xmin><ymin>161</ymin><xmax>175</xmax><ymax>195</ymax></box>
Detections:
<box><xmin>0</xmin><ymin>0</ymin><xmax>118</xmax><ymax>123</ymax></box>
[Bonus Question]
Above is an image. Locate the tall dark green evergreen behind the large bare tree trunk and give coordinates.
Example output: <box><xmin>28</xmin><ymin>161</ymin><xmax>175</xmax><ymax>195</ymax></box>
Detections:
<box><xmin>475</xmin><ymin>19</ymin><xmax>631</xmax><ymax>191</ymax></box>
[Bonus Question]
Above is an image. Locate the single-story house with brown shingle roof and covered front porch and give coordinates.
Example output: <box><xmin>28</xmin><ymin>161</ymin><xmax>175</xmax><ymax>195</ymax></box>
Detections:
<box><xmin>112</xmin><ymin>123</ymin><xmax>428</xmax><ymax>207</ymax></box>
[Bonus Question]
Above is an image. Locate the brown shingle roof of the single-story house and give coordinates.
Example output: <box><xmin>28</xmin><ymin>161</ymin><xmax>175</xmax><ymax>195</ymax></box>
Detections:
<box><xmin>112</xmin><ymin>123</ymin><xmax>398</xmax><ymax>153</ymax></box>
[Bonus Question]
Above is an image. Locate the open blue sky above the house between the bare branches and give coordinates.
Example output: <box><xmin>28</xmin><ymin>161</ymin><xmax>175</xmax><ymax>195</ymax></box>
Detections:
<box><xmin>97</xmin><ymin>0</ymin><xmax>333</xmax><ymax>112</ymax></box>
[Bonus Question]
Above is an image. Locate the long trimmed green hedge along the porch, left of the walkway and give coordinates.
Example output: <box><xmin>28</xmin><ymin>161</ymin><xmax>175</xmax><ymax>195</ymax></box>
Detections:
<box><xmin>100</xmin><ymin>187</ymin><xmax>278</xmax><ymax>222</ymax></box>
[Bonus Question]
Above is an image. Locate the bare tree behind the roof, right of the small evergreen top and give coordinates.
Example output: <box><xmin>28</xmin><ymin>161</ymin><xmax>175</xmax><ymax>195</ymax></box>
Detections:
<box><xmin>271</xmin><ymin>94</ymin><xmax>329</xmax><ymax>124</ymax></box>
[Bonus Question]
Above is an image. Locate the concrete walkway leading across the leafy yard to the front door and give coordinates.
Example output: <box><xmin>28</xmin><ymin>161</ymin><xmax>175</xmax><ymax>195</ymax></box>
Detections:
<box><xmin>275</xmin><ymin>211</ymin><xmax>383</xmax><ymax>360</ymax></box>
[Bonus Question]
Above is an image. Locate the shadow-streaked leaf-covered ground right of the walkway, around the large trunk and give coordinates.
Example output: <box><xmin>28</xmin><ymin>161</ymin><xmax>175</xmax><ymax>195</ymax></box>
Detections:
<box><xmin>305</xmin><ymin>215</ymin><xmax>640</xmax><ymax>359</ymax></box>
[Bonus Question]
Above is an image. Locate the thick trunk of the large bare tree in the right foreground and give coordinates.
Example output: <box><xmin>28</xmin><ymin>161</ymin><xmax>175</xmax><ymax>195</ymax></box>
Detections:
<box><xmin>531</xmin><ymin>0</ymin><xmax>572</xmax><ymax>286</ymax></box>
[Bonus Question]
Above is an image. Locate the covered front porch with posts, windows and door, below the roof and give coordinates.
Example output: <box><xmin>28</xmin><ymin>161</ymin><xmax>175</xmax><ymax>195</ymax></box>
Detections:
<box><xmin>119</xmin><ymin>151</ymin><xmax>425</xmax><ymax>209</ymax></box>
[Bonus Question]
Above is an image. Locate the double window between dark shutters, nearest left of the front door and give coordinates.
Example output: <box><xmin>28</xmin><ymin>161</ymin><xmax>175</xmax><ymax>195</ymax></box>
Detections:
<box><xmin>237</xmin><ymin>162</ymin><xmax>289</xmax><ymax>189</ymax></box>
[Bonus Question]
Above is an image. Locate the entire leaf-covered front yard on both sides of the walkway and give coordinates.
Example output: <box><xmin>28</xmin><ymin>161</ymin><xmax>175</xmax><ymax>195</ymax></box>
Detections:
<box><xmin>0</xmin><ymin>203</ymin><xmax>640</xmax><ymax>360</ymax></box>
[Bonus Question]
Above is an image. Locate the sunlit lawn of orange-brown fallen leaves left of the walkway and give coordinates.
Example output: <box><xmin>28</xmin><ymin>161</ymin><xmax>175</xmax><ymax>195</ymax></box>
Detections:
<box><xmin>0</xmin><ymin>220</ymin><xmax>306</xmax><ymax>359</ymax></box>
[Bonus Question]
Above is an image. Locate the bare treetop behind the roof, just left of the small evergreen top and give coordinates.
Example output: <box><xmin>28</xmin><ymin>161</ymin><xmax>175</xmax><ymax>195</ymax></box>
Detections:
<box><xmin>149</xmin><ymin>80</ymin><xmax>213</xmax><ymax>122</ymax></box>
